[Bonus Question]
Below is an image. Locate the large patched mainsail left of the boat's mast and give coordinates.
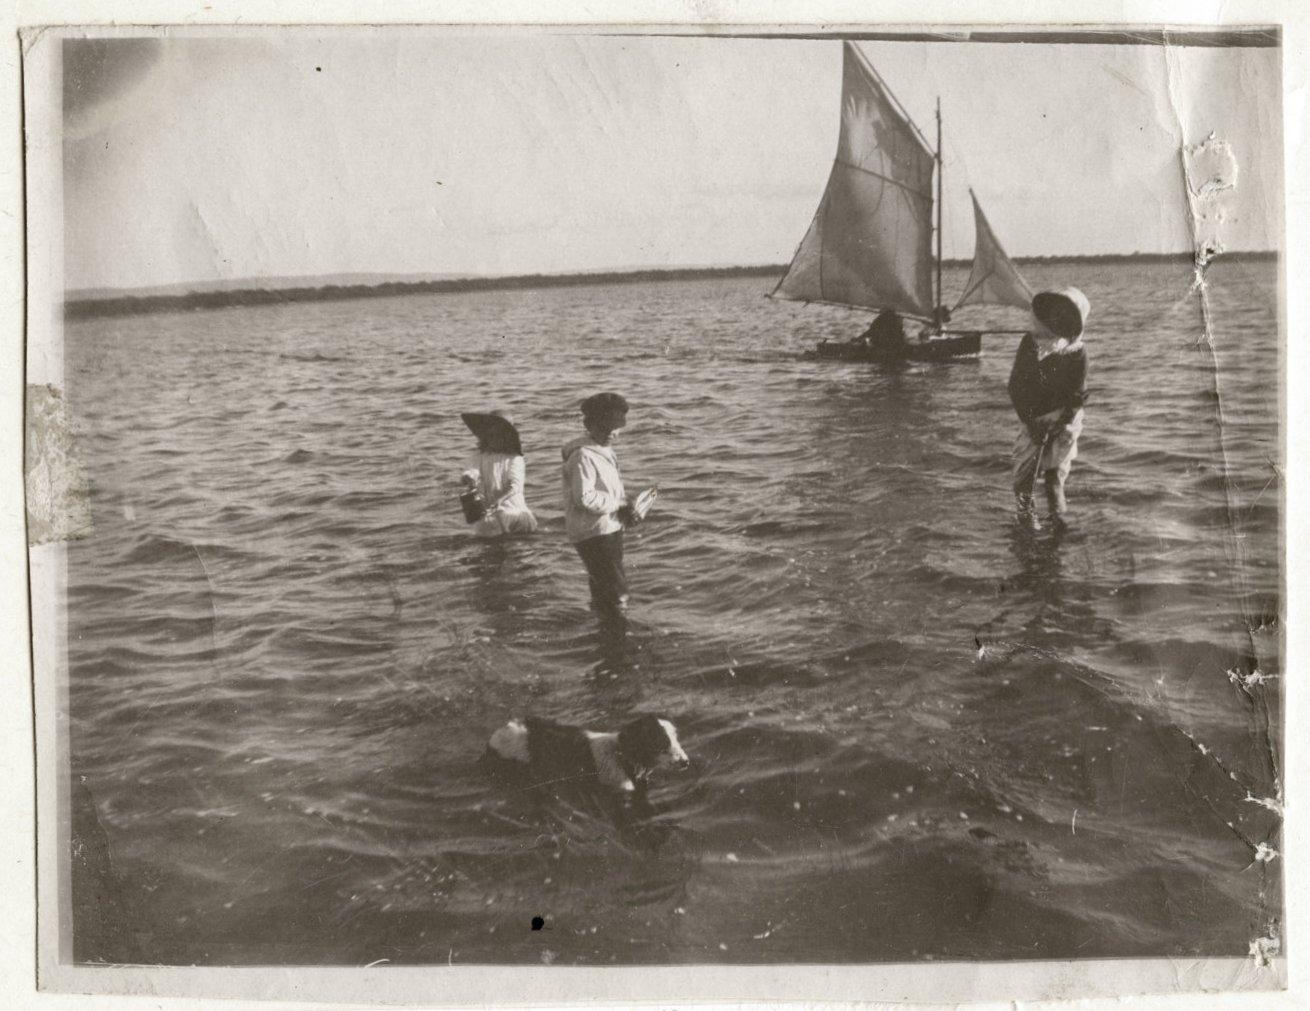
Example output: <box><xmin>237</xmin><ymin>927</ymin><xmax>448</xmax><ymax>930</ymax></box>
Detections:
<box><xmin>773</xmin><ymin>42</ymin><xmax>937</xmax><ymax>318</ymax></box>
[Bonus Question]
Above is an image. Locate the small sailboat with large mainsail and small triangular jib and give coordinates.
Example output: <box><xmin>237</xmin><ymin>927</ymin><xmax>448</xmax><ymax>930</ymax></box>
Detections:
<box><xmin>770</xmin><ymin>42</ymin><xmax>1032</xmax><ymax>360</ymax></box>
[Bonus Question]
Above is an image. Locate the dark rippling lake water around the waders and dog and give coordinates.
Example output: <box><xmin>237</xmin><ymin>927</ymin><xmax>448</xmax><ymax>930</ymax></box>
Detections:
<box><xmin>67</xmin><ymin>261</ymin><xmax>1282</xmax><ymax>964</ymax></box>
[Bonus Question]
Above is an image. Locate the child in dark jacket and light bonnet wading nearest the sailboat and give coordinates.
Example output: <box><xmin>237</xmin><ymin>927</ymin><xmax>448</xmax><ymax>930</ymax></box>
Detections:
<box><xmin>1009</xmin><ymin>288</ymin><xmax>1091</xmax><ymax>530</ymax></box>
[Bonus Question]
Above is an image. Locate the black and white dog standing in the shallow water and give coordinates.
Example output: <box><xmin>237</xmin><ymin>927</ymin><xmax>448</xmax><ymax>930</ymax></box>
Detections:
<box><xmin>487</xmin><ymin>716</ymin><xmax>690</xmax><ymax>794</ymax></box>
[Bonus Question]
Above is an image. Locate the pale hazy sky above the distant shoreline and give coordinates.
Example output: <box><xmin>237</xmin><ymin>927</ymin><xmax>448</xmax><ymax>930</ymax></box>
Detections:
<box><xmin>52</xmin><ymin>28</ymin><xmax>1282</xmax><ymax>289</ymax></box>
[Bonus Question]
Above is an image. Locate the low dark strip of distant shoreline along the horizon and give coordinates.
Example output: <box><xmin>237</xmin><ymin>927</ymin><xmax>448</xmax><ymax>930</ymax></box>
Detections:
<box><xmin>64</xmin><ymin>250</ymin><xmax>1279</xmax><ymax>320</ymax></box>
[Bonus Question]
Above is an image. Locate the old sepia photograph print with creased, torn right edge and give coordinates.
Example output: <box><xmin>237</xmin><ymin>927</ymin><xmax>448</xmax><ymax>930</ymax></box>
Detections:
<box><xmin>24</xmin><ymin>25</ymin><xmax>1285</xmax><ymax>986</ymax></box>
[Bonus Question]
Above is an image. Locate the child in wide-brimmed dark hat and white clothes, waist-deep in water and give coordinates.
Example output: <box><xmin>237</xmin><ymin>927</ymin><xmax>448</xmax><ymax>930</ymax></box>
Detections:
<box><xmin>460</xmin><ymin>411</ymin><xmax>537</xmax><ymax>537</ymax></box>
